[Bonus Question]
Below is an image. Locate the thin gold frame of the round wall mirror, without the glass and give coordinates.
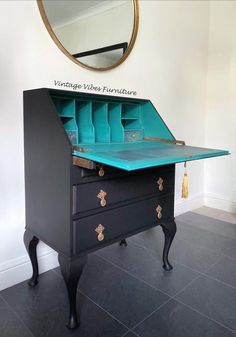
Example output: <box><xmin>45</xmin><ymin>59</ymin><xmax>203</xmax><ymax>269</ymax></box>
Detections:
<box><xmin>36</xmin><ymin>0</ymin><xmax>139</xmax><ymax>71</ymax></box>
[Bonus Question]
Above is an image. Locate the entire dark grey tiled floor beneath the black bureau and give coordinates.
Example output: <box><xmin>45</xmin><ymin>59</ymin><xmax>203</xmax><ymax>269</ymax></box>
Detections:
<box><xmin>0</xmin><ymin>212</ymin><xmax>236</xmax><ymax>337</ymax></box>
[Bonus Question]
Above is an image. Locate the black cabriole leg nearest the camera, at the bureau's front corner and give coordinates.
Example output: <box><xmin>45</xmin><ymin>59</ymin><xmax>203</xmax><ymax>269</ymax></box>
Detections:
<box><xmin>58</xmin><ymin>253</ymin><xmax>87</xmax><ymax>329</ymax></box>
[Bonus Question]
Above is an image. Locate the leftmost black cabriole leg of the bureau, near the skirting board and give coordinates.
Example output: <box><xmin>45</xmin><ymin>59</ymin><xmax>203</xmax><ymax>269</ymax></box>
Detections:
<box><xmin>24</xmin><ymin>229</ymin><xmax>39</xmax><ymax>287</ymax></box>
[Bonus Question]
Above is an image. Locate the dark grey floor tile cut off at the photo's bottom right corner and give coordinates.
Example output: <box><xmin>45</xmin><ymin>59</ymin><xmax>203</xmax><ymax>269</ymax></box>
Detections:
<box><xmin>134</xmin><ymin>300</ymin><xmax>234</xmax><ymax>337</ymax></box>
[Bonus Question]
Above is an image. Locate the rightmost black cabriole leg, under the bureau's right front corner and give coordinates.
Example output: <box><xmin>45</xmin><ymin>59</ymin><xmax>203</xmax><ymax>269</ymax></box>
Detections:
<box><xmin>161</xmin><ymin>220</ymin><xmax>176</xmax><ymax>271</ymax></box>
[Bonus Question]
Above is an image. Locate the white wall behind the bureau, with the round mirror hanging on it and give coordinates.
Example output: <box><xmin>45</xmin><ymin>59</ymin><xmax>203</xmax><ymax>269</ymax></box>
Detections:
<box><xmin>0</xmin><ymin>0</ymin><xmax>212</xmax><ymax>289</ymax></box>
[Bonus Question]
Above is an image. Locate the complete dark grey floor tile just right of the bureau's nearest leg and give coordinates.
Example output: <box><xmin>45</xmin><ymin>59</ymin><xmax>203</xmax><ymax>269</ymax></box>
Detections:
<box><xmin>79</xmin><ymin>255</ymin><xmax>169</xmax><ymax>327</ymax></box>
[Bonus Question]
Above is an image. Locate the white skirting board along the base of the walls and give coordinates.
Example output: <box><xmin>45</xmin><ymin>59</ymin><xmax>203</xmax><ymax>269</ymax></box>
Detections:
<box><xmin>3</xmin><ymin>194</ymin><xmax>236</xmax><ymax>290</ymax></box>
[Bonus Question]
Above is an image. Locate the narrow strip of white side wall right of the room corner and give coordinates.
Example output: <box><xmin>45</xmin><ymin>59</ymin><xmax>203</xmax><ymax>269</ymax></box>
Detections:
<box><xmin>205</xmin><ymin>1</ymin><xmax>236</xmax><ymax>213</ymax></box>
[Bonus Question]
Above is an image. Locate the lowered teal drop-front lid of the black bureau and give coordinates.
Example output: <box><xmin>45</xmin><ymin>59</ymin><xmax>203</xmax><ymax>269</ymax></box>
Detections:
<box><xmin>73</xmin><ymin>140</ymin><xmax>229</xmax><ymax>171</ymax></box>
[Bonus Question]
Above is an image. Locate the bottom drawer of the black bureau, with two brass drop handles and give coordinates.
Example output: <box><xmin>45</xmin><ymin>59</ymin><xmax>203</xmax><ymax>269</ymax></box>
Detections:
<box><xmin>73</xmin><ymin>194</ymin><xmax>174</xmax><ymax>254</ymax></box>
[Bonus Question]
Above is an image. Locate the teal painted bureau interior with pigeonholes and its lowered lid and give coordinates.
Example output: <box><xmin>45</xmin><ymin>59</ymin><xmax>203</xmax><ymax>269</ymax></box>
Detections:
<box><xmin>52</xmin><ymin>92</ymin><xmax>229</xmax><ymax>171</ymax></box>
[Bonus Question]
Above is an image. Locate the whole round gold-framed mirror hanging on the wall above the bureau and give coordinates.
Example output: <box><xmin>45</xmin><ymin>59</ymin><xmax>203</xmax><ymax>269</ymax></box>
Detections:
<box><xmin>37</xmin><ymin>0</ymin><xmax>139</xmax><ymax>71</ymax></box>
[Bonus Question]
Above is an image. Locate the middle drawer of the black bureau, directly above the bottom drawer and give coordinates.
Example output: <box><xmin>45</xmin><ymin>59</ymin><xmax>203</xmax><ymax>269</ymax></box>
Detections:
<box><xmin>73</xmin><ymin>169</ymin><xmax>174</xmax><ymax>215</ymax></box>
